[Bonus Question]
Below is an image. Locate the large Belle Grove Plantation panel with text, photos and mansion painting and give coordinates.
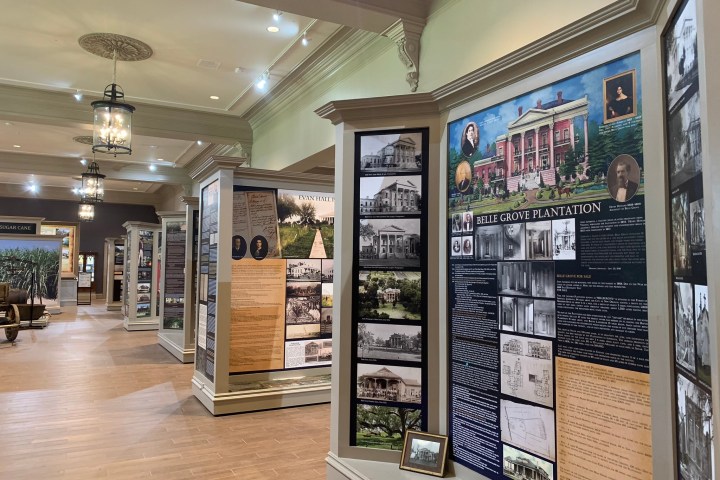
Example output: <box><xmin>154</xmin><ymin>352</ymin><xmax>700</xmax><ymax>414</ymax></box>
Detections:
<box><xmin>446</xmin><ymin>34</ymin><xmax>656</xmax><ymax>479</ymax></box>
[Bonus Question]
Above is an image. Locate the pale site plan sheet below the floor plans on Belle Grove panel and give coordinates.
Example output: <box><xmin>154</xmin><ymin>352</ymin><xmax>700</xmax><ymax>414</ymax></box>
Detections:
<box><xmin>500</xmin><ymin>399</ymin><xmax>555</xmax><ymax>462</ymax></box>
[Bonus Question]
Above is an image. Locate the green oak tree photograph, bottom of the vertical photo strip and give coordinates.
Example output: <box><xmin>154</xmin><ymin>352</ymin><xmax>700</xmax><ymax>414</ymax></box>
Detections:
<box><xmin>355</xmin><ymin>405</ymin><xmax>421</xmax><ymax>451</ymax></box>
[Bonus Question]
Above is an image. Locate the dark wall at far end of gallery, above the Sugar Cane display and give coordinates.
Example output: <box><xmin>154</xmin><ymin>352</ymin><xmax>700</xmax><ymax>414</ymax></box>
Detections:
<box><xmin>0</xmin><ymin>198</ymin><xmax>159</xmax><ymax>293</ymax></box>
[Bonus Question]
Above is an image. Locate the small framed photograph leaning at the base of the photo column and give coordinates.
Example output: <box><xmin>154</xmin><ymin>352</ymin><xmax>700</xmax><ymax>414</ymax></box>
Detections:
<box><xmin>400</xmin><ymin>430</ymin><xmax>448</xmax><ymax>477</ymax></box>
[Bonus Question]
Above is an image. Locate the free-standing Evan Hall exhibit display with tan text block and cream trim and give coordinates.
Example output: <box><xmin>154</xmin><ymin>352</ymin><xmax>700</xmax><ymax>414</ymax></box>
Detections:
<box><xmin>193</xmin><ymin>158</ymin><xmax>335</xmax><ymax>415</ymax></box>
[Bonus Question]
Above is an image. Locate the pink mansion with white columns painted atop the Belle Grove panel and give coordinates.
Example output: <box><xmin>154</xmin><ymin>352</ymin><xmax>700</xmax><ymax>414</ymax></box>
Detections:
<box><xmin>473</xmin><ymin>92</ymin><xmax>588</xmax><ymax>192</ymax></box>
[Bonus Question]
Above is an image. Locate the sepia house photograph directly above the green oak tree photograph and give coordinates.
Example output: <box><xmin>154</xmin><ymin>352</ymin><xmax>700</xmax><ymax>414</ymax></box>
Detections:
<box><xmin>357</xmin><ymin>363</ymin><xmax>422</xmax><ymax>404</ymax></box>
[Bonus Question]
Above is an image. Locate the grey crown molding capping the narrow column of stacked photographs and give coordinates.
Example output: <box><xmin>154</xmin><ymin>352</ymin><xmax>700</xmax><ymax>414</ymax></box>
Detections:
<box><xmin>315</xmin><ymin>93</ymin><xmax>440</xmax><ymax>125</ymax></box>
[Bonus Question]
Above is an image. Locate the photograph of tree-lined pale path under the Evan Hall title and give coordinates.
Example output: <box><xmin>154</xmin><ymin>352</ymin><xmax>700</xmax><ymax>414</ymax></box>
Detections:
<box><xmin>277</xmin><ymin>190</ymin><xmax>335</xmax><ymax>258</ymax></box>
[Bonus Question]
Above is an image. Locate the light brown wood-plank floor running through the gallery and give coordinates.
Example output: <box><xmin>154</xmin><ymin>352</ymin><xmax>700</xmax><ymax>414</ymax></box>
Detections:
<box><xmin>0</xmin><ymin>301</ymin><xmax>329</xmax><ymax>480</ymax></box>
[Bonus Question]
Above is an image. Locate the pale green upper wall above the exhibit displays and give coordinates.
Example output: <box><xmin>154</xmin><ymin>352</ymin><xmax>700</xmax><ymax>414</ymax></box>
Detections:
<box><xmin>252</xmin><ymin>0</ymin><xmax>614</xmax><ymax>170</ymax></box>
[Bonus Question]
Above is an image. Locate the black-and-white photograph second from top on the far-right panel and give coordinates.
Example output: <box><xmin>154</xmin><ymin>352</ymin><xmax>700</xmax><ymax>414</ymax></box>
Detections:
<box><xmin>668</xmin><ymin>92</ymin><xmax>702</xmax><ymax>188</ymax></box>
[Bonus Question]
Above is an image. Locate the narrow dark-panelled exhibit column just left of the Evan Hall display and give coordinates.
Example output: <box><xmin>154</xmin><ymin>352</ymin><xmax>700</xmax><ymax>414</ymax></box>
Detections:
<box><xmin>157</xmin><ymin>211</ymin><xmax>194</xmax><ymax>363</ymax></box>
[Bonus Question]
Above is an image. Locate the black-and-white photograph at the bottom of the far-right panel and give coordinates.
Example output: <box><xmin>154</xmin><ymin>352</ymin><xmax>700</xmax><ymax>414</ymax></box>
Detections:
<box><xmin>677</xmin><ymin>374</ymin><xmax>715</xmax><ymax>480</ymax></box>
